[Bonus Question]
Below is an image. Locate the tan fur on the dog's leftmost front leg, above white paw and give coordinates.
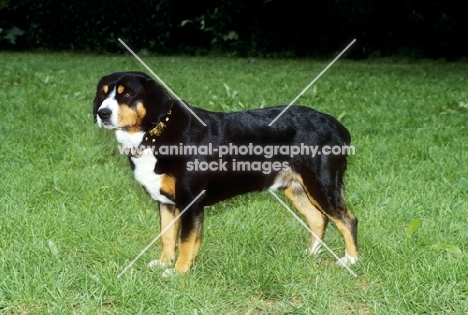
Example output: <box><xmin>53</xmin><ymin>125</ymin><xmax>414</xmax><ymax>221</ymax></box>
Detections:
<box><xmin>159</xmin><ymin>204</ymin><xmax>180</xmax><ymax>265</ymax></box>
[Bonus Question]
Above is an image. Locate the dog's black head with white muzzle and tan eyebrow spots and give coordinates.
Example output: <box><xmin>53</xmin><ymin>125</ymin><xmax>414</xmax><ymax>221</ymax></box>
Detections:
<box><xmin>93</xmin><ymin>72</ymin><xmax>172</xmax><ymax>132</ymax></box>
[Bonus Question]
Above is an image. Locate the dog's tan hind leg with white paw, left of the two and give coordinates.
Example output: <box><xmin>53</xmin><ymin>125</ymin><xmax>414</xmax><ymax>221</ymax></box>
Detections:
<box><xmin>284</xmin><ymin>181</ymin><xmax>328</xmax><ymax>255</ymax></box>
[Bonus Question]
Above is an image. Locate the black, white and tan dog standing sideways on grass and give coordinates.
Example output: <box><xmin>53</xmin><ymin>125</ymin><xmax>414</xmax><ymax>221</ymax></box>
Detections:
<box><xmin>94</xmin><ymin>72</ymin><xmax>358</xmax><ymax>273</ymax></box>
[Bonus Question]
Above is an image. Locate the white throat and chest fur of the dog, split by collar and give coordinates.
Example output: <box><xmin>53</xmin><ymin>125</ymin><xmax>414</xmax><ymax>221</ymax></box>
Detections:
<box><xmin>115</xmin><ymin>130</ymin><xmax>174</xmax><ymax>204</ymax></box>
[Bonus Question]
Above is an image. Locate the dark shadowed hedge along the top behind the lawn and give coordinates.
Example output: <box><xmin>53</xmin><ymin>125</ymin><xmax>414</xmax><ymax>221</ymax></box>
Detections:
<box><xmin>0</xmin><ymin>0</ymin><xmax>468</xmax><ymax>59</ymax></box>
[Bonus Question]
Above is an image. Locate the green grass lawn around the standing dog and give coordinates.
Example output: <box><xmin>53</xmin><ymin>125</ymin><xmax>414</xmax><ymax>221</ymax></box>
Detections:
<box><xmin>0</xmin><ymin>53</ymin><xmax>468</xmax><ymax>315</ymax></box>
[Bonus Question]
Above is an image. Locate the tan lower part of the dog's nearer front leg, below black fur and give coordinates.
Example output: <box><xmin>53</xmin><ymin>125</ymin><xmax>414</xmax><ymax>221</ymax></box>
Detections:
<box><xmin>174</xmin><ymin>223</ymin><xmax>203</xmax><ymax>274</ymax></box>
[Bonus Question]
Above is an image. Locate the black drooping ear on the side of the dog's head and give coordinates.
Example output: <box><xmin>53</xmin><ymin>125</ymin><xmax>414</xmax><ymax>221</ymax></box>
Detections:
<box><xmin>143</xmin><ymin>77</ymin><xmax>173</xmax><ymax>124</ymax></box>
